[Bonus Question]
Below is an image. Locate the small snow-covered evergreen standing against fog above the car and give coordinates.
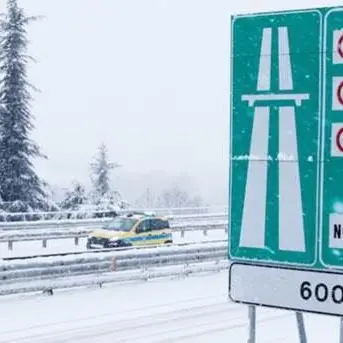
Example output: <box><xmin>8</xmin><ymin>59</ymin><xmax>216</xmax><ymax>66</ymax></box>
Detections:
<box><xmin>91</xmin><ymin>143</ymin><xmax>120</xmax><ymax>204</ymax></box>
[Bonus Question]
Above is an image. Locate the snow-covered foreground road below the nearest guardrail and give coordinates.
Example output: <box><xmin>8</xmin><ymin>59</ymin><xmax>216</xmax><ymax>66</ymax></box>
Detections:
<box><xmin>0</xmin><ymin>272</ymin><xmax>339</xmax><ymax>343</ymax></box>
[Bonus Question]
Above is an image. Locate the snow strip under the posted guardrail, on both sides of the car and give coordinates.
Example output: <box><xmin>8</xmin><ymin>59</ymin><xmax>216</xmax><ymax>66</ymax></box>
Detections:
<box><xmin>0</xmin><ymin>230</ymin><xmax>227</xmax><ymax>258</ymax></box>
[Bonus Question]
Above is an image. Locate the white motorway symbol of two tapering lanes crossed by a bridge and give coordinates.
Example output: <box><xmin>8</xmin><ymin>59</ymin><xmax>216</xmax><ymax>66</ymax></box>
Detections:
<box><xmin>240</xmin><ymin>27</ymin><xmax>310</xmax><ymax>252</ymax></box>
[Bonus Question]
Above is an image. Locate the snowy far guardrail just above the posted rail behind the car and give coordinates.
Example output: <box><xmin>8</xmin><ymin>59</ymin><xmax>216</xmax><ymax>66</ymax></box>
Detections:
<box><xmin>0</xmin><ymin>212</ymin><xmax>227</xmax><ymax>231</ymax></box>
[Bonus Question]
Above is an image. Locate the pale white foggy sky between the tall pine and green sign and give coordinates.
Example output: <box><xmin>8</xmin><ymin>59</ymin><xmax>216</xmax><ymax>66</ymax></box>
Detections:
<box><xmin>0</xmin><ymin>0</ymin><xmax>340</xmax><ymax>202</ymax></box>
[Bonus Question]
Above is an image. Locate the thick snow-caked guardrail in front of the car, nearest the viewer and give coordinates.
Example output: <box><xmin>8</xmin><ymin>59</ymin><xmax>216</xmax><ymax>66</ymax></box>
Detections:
<box><xmin>0</xmin><ymin>242</ymin><xmax>228</xmax><ymax>295</ymax></box>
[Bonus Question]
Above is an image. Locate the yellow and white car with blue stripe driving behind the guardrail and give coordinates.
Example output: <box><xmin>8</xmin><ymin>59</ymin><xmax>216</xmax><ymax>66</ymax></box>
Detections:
<box><xmin>87</xmin><ymin>213</ymin><xmax>173</xmax><ymax>249</ymax></box>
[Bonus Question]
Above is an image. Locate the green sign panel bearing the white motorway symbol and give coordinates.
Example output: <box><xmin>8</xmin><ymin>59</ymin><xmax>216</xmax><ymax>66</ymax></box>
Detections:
<box><xmin>230</xmin><ymin>11</ymin><xmax>321</xmax><ymax>265</ymax></box>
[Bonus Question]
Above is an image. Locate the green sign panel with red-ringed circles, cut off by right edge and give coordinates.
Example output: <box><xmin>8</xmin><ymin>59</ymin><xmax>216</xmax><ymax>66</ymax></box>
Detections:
<box><xmin>320</xmin><ymin>8</ymin><xmax>343</xmax><ymax>268</ymax></box>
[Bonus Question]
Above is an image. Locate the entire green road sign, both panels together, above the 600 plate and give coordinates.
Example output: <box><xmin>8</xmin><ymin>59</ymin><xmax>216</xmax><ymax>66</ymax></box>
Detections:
<box><xmin>229</xmin><ymin>8</ymin><xmax>343</xmax><ymax>269</ymax></box>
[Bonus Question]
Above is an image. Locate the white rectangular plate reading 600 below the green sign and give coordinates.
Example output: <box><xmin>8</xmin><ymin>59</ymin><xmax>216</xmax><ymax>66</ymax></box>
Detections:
<box><xmin>229</xmin><ymin>263</ymin><xmax>343</xmax><ymax>316</ymax></box>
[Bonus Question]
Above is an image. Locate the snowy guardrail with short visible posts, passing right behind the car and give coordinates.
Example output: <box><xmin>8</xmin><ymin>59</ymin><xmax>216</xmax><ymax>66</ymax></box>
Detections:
<box><xmin>0</xmin><ymin>221</ymin><xmax>227</xmax><ymax>250</ymax></box>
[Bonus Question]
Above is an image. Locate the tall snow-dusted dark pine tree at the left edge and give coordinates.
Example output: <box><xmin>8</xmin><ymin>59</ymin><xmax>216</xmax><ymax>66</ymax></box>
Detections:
<box><xmin>0</xmin><ymin>0</ymin><xmax>46</xmax><ymax>208</ymax></box>
